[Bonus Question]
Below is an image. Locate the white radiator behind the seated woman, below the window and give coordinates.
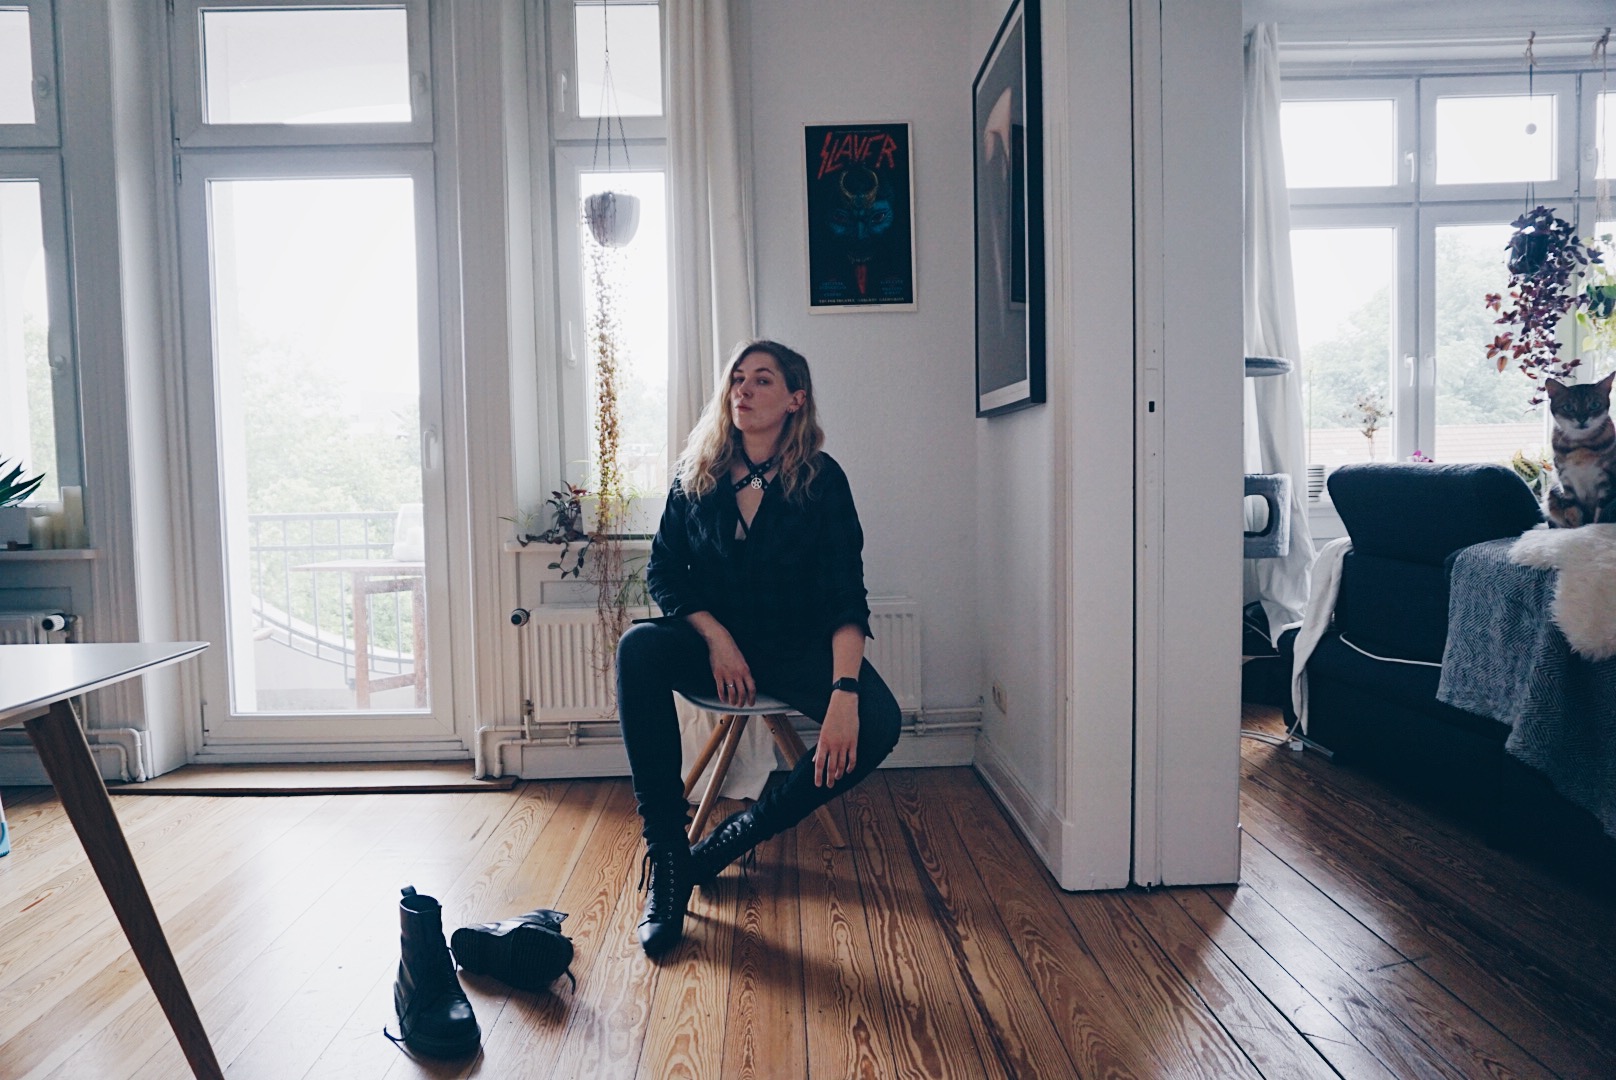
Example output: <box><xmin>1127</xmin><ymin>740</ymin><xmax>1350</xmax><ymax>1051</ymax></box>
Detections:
<box><xmin>520</xmin><ymin>597</ymin><xmax>921</xmax><ymax>723</ymax></box>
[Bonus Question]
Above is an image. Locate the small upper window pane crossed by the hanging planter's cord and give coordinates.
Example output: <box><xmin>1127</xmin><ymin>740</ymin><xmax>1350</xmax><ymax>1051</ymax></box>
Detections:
<box><xmin>574</xmin><ymin>3</ymin><xmax>663</xmax><ymax>116</ymax></box>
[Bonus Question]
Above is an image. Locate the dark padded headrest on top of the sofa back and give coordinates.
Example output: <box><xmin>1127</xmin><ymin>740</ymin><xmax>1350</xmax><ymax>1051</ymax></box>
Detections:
<box><xmin>1328</xmin><ymin>462</ymin><xmax>1542</xmax><ymax>566</ymax></box>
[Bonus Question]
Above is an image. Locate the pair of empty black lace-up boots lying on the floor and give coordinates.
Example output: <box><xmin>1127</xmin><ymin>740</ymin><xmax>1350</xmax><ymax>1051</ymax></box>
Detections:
<box><xmin>389</xmin><ymin>886</ymin><xmax>572</xmax><ymax>1059</ymax></box>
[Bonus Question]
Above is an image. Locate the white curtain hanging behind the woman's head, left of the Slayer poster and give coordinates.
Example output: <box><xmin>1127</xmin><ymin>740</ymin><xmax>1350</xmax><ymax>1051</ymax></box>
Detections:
<box><xmin>664</xmin><ymin>0</ymin><xmax>755</xmax><ymax>454</ymax></box>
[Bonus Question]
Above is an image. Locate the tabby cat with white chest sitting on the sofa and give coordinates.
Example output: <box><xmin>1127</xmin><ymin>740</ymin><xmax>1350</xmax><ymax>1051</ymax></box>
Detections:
<box><xmin>1543</xmin><ymin>372</ymin><xmax>1616</xmax><ymax>529</ymax></box>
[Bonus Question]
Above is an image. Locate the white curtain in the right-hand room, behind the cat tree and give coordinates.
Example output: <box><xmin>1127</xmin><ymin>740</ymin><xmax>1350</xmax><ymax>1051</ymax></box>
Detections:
<box><xmin>1244</xmin><ymin>23</ymin><xmax>1314</xmax><ymax>637</ymax></box>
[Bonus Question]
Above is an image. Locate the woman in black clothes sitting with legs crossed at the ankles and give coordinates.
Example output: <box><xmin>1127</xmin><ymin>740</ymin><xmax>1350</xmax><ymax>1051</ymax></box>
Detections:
<box><xmin>617</xmin><ymin>341</ymin><xmax>900</xmax><ymax>956</ymax></box>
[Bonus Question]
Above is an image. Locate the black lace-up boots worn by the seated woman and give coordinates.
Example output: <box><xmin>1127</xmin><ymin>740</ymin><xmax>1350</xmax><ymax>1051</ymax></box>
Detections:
<box><xmin>637</xmin><ymin>804</ymin><xmax>779</xmax><ymax>957</ymax></box>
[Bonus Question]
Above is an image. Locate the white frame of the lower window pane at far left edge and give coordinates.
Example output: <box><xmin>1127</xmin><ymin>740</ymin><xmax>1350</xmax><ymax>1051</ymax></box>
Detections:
<box><xmin>0</xmin><ymin>150</ymin><xmax>84</xmax><ymax>485</ymax></box>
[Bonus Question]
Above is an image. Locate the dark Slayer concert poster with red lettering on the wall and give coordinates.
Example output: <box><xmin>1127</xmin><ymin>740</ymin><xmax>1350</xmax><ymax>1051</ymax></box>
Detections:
<box><xmin>803</xmin><ymin>123</ymin><xmax>915</xmax><ymax>312</ymax></box>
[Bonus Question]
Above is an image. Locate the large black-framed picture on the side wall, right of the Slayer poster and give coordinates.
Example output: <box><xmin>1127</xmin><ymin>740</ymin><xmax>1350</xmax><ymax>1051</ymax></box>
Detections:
<box><xmin>971</xmin><ymin>0</ymin><xmax>1046</xmax><ymax>417</ymax></box>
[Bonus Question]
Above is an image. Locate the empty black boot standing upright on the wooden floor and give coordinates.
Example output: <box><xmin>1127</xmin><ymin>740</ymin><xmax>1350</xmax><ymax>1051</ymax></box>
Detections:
<box><xmin>393</xmin><ymin>886</ymin><xmax>482</xmax><ymax>1057</ymax></box>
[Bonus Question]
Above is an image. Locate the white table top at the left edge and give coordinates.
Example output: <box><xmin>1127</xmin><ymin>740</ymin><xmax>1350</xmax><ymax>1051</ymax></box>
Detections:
<box><xmin>0</xmin><ymin>642</ymin><xmax>208</xmax><ymax>728</ymax></box>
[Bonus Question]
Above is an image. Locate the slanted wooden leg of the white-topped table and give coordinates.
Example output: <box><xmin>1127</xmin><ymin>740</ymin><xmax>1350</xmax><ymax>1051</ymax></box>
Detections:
<box><xmin>26</xmin><ymin>702</ymin><xmax>225</xmax><ymax>1080</ymax></box>
